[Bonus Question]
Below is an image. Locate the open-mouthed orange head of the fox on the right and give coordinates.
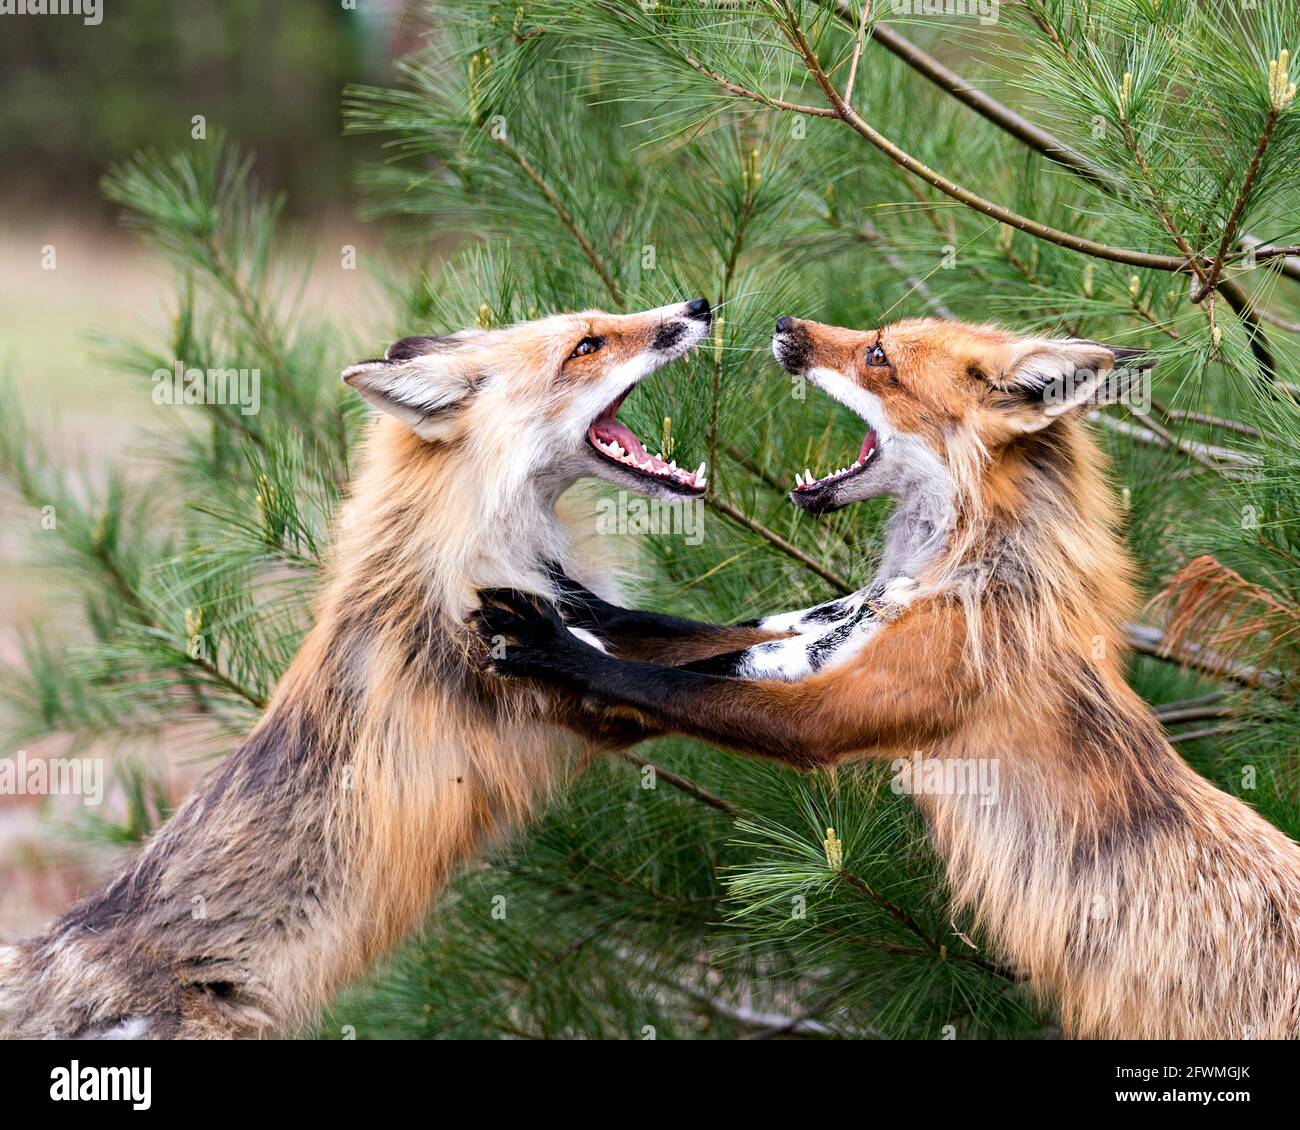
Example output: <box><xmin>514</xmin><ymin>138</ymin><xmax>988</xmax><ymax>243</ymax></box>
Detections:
<box><xmin>772</xmin><ymin>317</ymin><xmax>1140</xmax><ymax>512</ymax></box>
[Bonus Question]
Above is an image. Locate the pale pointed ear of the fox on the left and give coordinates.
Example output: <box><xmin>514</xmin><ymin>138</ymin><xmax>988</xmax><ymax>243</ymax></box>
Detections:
<box><xmin>343</xmin><ymin>333</ymin><xmax>480</xmax><ymax>441</ymax></box>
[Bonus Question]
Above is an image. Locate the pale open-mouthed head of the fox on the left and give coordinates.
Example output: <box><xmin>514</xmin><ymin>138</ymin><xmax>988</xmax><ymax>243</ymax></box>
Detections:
<box><xmin>343</xmin><ymin>298</ymin><xmax>712</xmax><ymax>498</ymax></box>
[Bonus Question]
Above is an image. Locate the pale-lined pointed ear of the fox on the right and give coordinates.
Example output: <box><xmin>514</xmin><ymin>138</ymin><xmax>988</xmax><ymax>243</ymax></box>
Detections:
<box><xmin>995</xmin><ymin>338</ymin><xmax>1156</xmax><ymax>432</ymax></box>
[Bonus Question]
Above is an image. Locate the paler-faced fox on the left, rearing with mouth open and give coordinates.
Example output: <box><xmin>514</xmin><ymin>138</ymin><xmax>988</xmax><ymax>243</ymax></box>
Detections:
<box><xmin>0</xmin><ymin>299</ymin><xmax>772</xmax><ymax>1038</ymax></box>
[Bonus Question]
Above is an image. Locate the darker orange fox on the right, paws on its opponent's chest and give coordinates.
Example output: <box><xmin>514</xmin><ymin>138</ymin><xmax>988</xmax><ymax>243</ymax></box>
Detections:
<box><xmin>480</xmin><ymin>317</ymin><xmax>1300</xmax><ymax>1039</ymax></box>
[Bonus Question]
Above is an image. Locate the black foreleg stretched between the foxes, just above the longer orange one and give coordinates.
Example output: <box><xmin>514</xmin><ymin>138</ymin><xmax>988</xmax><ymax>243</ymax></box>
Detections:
<box><xmin>547</xmin><ymin>563</ymin><xmax>788</xmax><ymax>666</ymax></box>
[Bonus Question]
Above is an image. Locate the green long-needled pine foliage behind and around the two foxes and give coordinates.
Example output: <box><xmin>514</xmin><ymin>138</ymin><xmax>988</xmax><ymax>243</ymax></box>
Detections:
<box><xmin>0</xmin><ymin>0</ymin><xmax>1300</xmax><ymax>1039</ymax></box>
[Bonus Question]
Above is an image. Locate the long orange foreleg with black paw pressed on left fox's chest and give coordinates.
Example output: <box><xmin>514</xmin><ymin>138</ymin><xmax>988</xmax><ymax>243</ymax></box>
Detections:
<box><xmin>480</xmin><ymin>594</ymin><xmax>975</xmax><ymax>767</ymax></box>
